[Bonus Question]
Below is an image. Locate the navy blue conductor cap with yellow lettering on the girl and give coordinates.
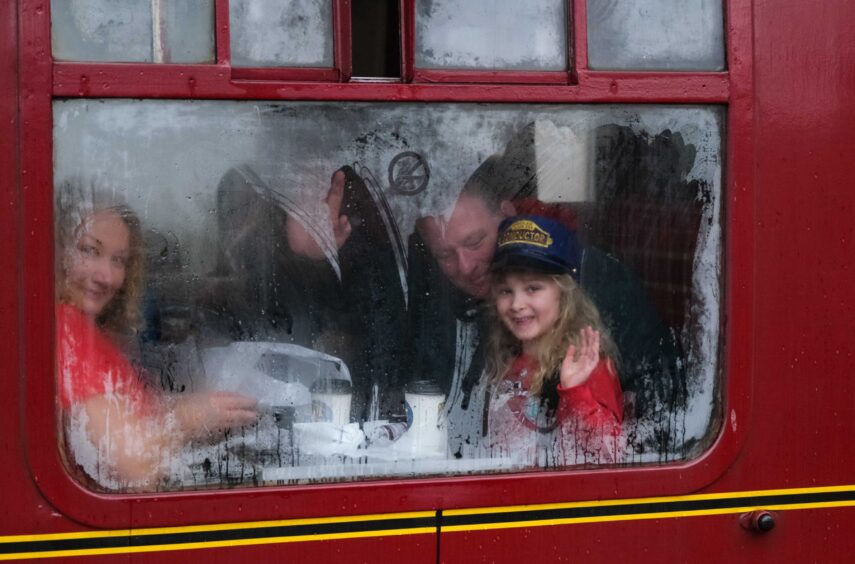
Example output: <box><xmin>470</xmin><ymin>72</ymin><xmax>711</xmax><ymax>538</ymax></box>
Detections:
<box><xmin>490</xmin><ymin>215</ymin><xmax>582</xmax><ymax>280</ymax></box>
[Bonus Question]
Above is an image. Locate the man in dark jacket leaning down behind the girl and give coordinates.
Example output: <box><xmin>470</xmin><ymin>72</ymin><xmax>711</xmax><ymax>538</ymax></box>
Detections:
<box><xmin>411</xmin><ymin>157</ymin><xmax>685</xmax><ymax>455</ymax></box>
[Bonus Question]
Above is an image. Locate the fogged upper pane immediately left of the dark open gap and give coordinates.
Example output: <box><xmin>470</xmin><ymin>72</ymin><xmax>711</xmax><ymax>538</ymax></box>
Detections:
<box><xmin>229</xmin><ymin>0</ymin><xmax>333</xmax><ymax>67</ymax></box>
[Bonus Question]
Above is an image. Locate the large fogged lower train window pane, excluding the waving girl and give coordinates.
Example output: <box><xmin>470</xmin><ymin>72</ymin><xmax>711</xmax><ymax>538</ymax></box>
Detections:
<box><xmin>54</xmin><ymin>99</ymin><xmax>725</xmax><ymax>491</ymax></box>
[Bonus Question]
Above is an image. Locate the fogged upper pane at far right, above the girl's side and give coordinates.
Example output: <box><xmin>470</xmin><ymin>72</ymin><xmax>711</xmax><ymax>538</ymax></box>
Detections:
<box><xmin>587</xmin><ymin>0</ymin><xmax>725</xmax><ymax>71</ymax></box>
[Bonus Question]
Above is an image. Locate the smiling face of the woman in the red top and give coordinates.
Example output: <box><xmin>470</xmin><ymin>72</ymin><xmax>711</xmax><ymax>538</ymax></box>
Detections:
<box><xmin>65</xmin><ymin>211</ymin><xmax>130</xmax><ymax>318</ymax></box>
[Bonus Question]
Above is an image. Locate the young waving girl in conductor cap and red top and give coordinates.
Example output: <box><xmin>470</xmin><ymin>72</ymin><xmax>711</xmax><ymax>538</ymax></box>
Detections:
<box><xmin>487</xmin><ymin>216</ymin><xmax>623</xmax><ymax>466</ymax></box>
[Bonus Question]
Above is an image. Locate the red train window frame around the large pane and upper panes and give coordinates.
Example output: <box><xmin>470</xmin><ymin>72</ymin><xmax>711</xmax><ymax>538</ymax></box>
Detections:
<box><xmin>16</xmin><ymin>0</ymin><xmax>754</xmax><ymax>528</ymax></box>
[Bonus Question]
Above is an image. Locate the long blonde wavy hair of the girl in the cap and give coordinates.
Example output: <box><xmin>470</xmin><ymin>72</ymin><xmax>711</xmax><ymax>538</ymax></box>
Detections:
<box><xmin>486</xmin><ymin>269</ymin><xmax>618</xmax><ymax>397</ymax></box>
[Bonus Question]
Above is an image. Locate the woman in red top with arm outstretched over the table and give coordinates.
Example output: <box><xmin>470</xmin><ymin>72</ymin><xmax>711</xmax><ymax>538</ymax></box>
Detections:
<box><xmin>56</xmin><ymin>189</ymin><xmax>257</xmax><ymax>489</ymax></box>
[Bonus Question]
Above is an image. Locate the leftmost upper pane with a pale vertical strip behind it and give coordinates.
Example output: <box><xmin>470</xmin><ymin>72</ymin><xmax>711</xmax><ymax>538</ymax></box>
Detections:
<box><xmin>51</xmin><ymin>0</ymin><xmax>214</xmax><ymax>63</ymax></box>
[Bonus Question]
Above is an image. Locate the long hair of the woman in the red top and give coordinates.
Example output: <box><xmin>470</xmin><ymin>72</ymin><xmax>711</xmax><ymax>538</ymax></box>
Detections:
<box><xmin>54</xmin><ymin>180</ymin><xmax>145</xmax><ymax>334</ymax></box>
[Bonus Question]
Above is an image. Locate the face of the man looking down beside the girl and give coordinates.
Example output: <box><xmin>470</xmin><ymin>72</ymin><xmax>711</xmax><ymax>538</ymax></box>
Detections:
<box><xmin>422</xmin><ymin>196</ymin><xmax>505</xmax><ymax>298</ymax></box>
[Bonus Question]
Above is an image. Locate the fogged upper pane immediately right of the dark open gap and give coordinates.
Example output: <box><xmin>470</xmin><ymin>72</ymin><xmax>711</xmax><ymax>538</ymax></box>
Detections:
<box><xmin>416</xmin><ymin>0</ymin><xmax>568</xmax><ymax>71</ymax></box>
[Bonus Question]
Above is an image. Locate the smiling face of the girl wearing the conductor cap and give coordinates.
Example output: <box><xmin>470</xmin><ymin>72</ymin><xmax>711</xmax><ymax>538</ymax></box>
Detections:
<box><xmin>493</xmin><ymin>274</ymin><xmax>561</xmax><ymax>355</ymax></box>
